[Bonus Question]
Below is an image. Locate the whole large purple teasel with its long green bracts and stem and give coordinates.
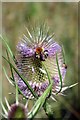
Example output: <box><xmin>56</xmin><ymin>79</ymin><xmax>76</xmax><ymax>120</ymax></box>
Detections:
<box><xmin>1</xmin><ymin>26</ymin><xmax>77</xmax><ymax>119</ymax></box>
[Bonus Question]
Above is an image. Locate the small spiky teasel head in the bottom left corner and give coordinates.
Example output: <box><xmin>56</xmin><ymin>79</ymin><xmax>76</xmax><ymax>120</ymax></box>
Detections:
<box><xmin>0</xmin><ymin>97</ymin><xmax>28</xmax><ymax>120</ymax></box>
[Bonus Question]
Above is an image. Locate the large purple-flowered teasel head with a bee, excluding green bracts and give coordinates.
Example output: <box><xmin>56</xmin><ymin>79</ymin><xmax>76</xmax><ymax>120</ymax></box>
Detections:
<box><xmin>15</xmin><ymin>27</ymin><xmax>67</xmax><ymax>99</ymax></box>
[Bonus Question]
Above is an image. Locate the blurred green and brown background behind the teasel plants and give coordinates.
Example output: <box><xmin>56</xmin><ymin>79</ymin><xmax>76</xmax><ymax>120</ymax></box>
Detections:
<box><xmin>2</xmin><ymin>2</ymin><xmax>79</xmax><ymax>120</ymax></box>
